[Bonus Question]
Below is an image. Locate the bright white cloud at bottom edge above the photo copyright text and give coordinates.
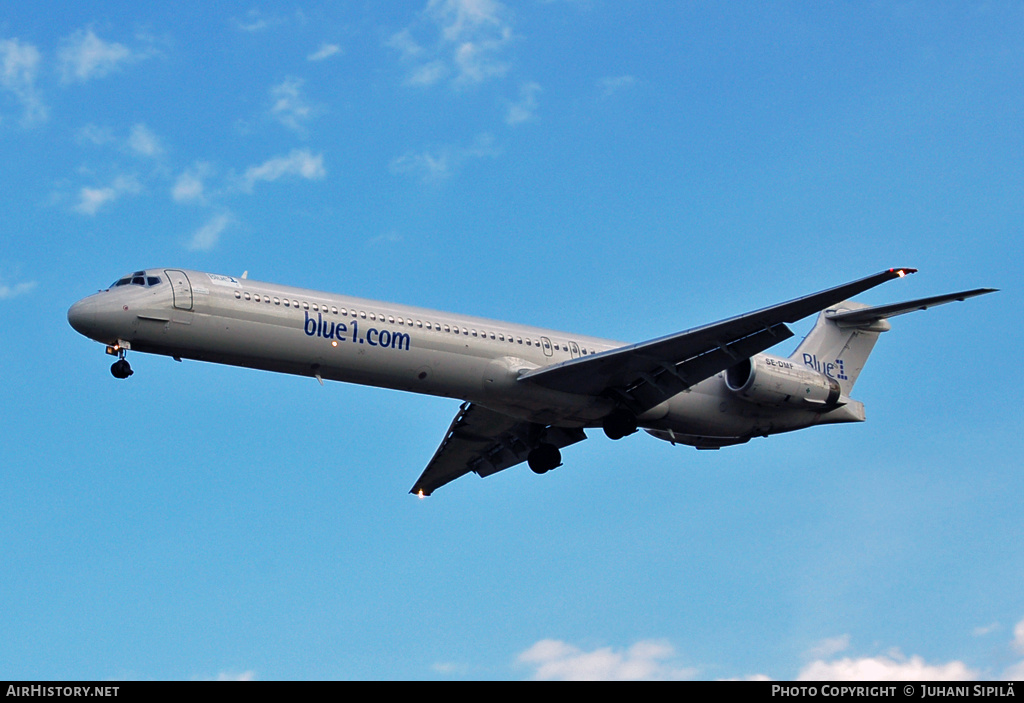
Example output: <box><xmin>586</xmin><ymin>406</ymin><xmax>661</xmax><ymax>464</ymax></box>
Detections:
<box><xmin>797</xmin><ymin>652</ymin><xmax>978</xmax><ymax>682</ymax></box>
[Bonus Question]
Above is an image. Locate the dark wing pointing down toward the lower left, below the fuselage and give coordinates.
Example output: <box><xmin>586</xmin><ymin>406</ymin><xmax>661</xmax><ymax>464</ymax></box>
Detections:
<box><xmin>410</xmin><ymin>403</ymin><xmax>587</xmax><ymax>495</ymax></box>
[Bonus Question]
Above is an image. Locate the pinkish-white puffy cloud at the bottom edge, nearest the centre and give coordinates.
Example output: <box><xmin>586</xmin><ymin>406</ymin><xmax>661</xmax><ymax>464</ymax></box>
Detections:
<box><xmin>517</xmin><ymin>640</ymin><xmax>696</xmax><ymax>680</ymax></box>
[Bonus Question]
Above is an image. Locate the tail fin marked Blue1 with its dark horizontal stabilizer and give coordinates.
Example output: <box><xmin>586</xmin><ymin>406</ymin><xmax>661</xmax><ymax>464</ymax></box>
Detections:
<box><xmin>790</xmin><ymin>289</ymin><xmax>994</xmax><ymax>396</ymax></box>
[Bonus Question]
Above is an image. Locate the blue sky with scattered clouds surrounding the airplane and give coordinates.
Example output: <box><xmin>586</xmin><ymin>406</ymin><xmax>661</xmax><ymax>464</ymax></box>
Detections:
<box><xmin>0</xmin><ymin>0</ymin><xmax>1024</xmax><ymax>679</ymax></box>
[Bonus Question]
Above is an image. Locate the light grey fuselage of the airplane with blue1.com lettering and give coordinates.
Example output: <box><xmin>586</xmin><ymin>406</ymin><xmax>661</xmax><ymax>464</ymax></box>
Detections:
<box><xmin>69</xmin><ymin>269</ymin><xmax>859</xmax><ymax>447</ymax></box>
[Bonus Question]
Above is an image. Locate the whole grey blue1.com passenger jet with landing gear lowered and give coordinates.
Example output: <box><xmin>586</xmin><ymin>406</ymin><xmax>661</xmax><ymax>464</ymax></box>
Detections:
<box><xmin>68</xmin><ymin>268</ymin><xmax>994</xmax><ymax>496</ymax></box>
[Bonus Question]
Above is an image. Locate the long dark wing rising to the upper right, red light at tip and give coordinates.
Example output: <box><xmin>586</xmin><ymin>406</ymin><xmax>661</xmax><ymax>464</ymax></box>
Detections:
<box><xmin>519</xmin><ymin>268</ymin><xmax>916</xmax><ymax>414</ymax></box>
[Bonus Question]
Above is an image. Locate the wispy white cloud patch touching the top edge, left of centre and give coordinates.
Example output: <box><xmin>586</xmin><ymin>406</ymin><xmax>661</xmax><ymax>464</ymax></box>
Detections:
<box><xmin>386</xmin><ymin>0</ymin><xmax>512</xmax><ymax>86</ymax></box>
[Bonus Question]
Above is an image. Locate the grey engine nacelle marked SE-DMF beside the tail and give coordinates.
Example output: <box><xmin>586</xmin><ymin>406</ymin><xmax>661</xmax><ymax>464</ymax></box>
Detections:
<box><xmin>725</xmin><ymin>356</ymin><xmax>843</xmax><ymax>412</ymax></box>
